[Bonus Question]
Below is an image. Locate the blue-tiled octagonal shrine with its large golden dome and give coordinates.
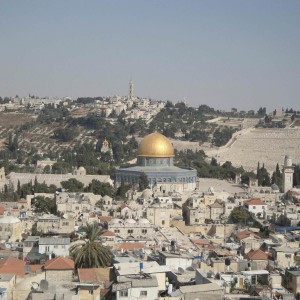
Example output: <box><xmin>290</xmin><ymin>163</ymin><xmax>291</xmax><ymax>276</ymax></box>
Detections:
<box><xmin>115</xmin><ymin>132</ymin><xmax>197</xmax><ymax>193</ymax></box>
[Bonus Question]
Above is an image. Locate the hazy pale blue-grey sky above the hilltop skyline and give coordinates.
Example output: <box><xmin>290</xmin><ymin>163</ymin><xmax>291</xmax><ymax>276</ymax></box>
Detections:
<box><xmin>0</xmin><ymin>0</ymin><xmax>300</xmax><ymax>111</ymax></box>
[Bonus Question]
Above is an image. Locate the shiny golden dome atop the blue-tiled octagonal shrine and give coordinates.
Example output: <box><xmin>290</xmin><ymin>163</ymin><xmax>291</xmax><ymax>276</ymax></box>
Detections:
<box><xmin>138</xmin><ymin>132</ymin><xmax>174</xmax><ymax>157</ymax></box>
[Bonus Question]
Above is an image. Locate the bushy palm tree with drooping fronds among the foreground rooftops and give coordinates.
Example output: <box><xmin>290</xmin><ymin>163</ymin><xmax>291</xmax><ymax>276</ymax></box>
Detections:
<box><xmin>69</xmin><ymin>223</ymin><xmax>112</xmax><ymax>268</ymax></box>
